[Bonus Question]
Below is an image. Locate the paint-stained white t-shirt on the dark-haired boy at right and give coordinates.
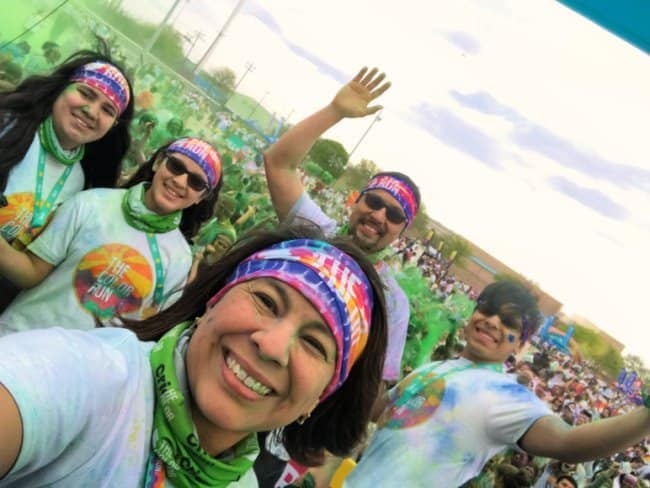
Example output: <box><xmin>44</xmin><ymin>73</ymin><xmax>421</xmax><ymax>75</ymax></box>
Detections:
<box><xmin>345</xmin><ymin>359</ymin><xmax>552</xmax><ymax>488</ymax></box>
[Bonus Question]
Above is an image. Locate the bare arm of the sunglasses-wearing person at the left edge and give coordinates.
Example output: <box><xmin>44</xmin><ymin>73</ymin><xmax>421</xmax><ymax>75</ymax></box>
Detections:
<box><xmin>0</xmin><ymin>238</ymin><xmax>54</xmax><ymax>288</ymax></box>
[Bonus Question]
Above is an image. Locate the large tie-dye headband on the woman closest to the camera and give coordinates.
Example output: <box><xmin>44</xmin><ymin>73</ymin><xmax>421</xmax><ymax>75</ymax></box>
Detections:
<box><xmin>208</xmin><ymin>239</ymin><xmax>373</xmax><ymax>400</ymax></box>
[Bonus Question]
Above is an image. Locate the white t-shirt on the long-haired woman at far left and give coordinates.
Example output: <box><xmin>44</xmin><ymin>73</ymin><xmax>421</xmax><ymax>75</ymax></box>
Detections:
<box><xmin>0</xmin><ymin>132</ymin><xmax>84</xmax><ymax>241</ymax></box>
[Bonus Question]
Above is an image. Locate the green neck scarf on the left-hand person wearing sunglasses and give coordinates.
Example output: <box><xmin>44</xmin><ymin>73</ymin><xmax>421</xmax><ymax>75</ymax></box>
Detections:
<box><xmin>122</xmin><ymin>183</ymin><xmax>183</xmax><ymax>234</ymax></box>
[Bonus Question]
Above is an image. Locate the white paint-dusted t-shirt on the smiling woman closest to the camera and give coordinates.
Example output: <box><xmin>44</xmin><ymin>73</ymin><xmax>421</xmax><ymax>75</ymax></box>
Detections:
<box><xmin>0</xmin><ymin>327</ymin><xmax>257</xmax><ymax>488</ymax></box>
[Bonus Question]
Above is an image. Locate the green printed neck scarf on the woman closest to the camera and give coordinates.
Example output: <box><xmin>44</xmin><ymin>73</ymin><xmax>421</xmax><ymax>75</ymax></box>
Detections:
<box><xmin>145</xmin><ymin>322</ymin><xmax>259</xmax><ymax>488</ymax></box>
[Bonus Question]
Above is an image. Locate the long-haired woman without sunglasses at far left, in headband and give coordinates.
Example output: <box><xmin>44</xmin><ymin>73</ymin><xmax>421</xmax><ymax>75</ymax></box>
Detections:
<box><xmin>0</xmin><ymin>51</ymin><xmax>133</xmax><ymax>311</ymax></box>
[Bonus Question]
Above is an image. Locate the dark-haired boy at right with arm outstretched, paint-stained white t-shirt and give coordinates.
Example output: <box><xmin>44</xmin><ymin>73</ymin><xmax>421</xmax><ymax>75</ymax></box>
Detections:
<box><xmin>345</xmin><ymin>282</ymin><xmax>650</xmax><ymax>488</ymax></box>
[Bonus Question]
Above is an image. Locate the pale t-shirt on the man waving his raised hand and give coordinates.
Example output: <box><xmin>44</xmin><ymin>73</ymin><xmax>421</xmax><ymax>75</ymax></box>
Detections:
<box><xmin>286</xmin><ymin>192</ymin><xmax>410</xmax><ymax>381</ymax></box>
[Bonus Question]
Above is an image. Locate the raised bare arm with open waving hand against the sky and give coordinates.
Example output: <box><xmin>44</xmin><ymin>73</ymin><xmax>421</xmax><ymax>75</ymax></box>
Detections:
<box><xmin>264</xmin><ymin>68</ymin><xmax>390</xmax><ymax>221</ymax></box>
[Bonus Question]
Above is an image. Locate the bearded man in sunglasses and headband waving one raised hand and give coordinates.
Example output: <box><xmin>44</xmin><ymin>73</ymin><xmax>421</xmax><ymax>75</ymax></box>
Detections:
<box><xmin>256</xmin><ymin>68</ymin><xmax>420</xmax><ymax>488</ymax></box>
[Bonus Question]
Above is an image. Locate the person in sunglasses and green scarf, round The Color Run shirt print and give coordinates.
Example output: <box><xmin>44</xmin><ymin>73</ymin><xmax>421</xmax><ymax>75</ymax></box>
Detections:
<box><xmin>0</xmin><ymin>138</ymin><xmax>221</xmax><ymax>334</ymax></box>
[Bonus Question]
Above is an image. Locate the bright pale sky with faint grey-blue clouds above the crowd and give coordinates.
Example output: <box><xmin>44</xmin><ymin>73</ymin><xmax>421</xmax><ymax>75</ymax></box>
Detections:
<box><xmin>124</xmin><ymin>0</ymin><xmax>650</xmax><ymax>365</ymax></box>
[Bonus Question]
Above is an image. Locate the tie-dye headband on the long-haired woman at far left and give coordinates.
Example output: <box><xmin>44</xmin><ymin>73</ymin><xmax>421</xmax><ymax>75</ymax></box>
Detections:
<box><xmin>70</xmin><ymin>61</ymin><xmax>131</xmax><ymax>114</ymax></box>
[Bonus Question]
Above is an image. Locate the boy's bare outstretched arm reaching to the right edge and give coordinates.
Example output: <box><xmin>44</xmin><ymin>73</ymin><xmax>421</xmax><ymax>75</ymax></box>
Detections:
<box><xmin>519</xmin><ymin>407</ymin><xmax>650</xmax><ymax>463</ymax></box>
